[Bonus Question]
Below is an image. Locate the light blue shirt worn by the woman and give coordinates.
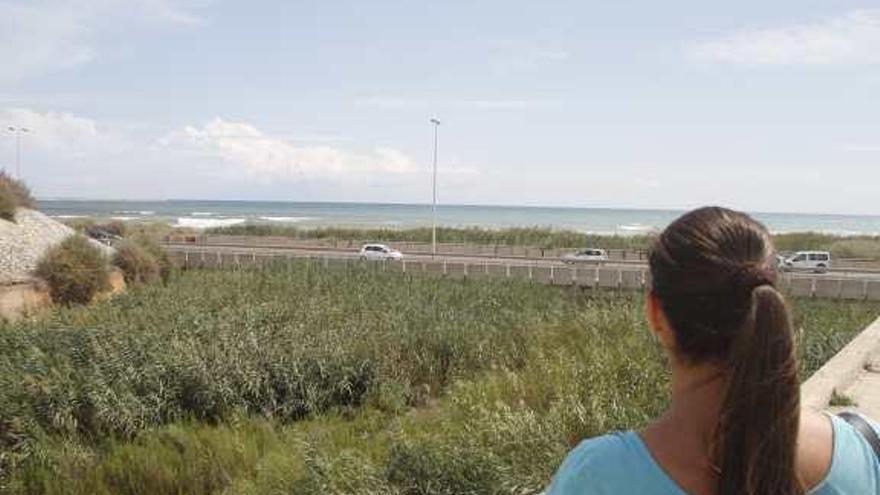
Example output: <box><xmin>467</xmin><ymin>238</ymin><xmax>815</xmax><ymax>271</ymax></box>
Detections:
<box><xmin>546</xmin><ymin>416</ymin><xmax>880</xmax><ymax>495</ymax></box>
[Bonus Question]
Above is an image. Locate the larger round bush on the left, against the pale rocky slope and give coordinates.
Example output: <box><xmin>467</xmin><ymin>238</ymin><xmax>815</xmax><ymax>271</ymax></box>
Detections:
<box><xmin>36</xmin><ymin>235</ymin><xmax>110</xmax><ymax>306</ymax></box>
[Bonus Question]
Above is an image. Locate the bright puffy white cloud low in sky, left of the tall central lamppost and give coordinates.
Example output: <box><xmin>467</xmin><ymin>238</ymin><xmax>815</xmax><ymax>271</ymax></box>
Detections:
<box><xmin>161</xmin><ymin>118</ymin><xmax>417</xmax><ymax>180</ymax></box>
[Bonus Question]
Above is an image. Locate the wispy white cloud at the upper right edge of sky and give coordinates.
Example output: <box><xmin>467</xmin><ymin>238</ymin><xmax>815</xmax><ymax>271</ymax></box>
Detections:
<box><xmin>686</xmin><ymin>9</ymin><xmax>880</xmax><ymax>65</ymax></box>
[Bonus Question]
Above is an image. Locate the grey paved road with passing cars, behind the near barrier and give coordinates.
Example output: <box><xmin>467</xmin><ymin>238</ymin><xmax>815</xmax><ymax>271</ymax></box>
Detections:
<box><xmin>168</xmin><ymin>244</ymin><xmax>880</xmax><ymax>280</ymax></box>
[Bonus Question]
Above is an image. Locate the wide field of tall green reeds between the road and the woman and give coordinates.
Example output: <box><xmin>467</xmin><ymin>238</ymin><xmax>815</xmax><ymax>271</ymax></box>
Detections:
<box><xmin>0</xmin><ymin>261</ymin><xmax>880</xmax><ymax>495</ymax></box>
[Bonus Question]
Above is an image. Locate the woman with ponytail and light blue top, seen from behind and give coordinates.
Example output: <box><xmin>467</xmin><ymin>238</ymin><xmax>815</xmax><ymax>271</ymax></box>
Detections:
<box><xmin>547</xmin><ymin>207</ymin><xmax>880</xmax><ymax>495</ymax></box>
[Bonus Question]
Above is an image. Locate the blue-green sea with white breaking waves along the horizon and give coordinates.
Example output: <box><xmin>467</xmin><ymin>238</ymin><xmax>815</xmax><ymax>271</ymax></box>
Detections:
<box><xmin>38</xmin><ymin>199</ymin><xmax>880</xmax><ymax>236</ymax></box>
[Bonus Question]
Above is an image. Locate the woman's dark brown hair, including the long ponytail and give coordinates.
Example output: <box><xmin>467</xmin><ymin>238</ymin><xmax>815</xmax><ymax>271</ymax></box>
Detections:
<box><xmin>650</xmin><ymin>207</ymin><xmax>805</xmax><ymax>495</ymax></box>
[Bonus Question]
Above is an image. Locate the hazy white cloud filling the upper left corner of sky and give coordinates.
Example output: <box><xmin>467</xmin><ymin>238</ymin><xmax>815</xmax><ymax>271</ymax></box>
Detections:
<box><xmin>0</xmin><ymin>0</ymin><xmax>201</xmax><ymax>84</ymax></box>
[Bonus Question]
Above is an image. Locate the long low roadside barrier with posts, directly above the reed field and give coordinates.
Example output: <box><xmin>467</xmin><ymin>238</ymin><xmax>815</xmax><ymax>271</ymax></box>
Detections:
<box><xmin>166</xmin><ymin>245</ymin><xmax>880</xmax><ymax>300</ymax></box>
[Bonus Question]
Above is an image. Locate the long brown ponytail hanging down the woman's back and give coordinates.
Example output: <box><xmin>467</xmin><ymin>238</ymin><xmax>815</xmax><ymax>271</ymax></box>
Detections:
<box><xmin>714</xmin><ymin>284</ymin><xmax>805</xmax><ymax>495</ymax></box>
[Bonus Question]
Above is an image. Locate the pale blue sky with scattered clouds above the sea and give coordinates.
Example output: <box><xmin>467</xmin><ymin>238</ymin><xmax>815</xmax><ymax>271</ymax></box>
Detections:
<box><xmin>0</xmin><ymin>0</ymin><xmax>880</xmax><ymax>214</ymax></box>
